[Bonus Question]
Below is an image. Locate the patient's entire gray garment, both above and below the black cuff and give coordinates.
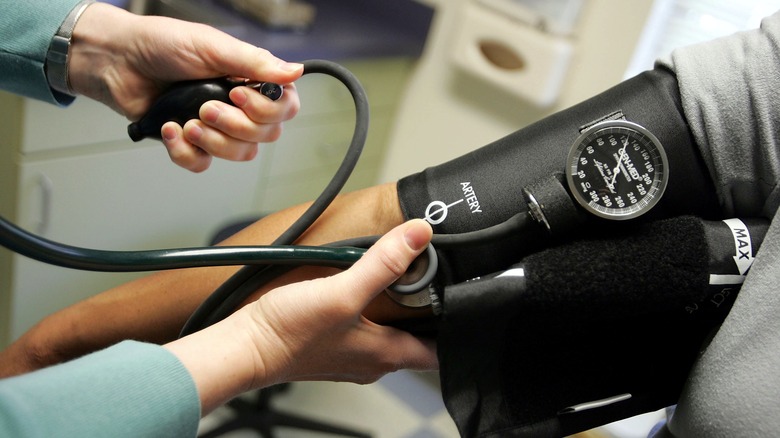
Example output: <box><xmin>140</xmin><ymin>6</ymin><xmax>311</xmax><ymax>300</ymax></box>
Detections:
<box><xmin>659</xmin><ymin>10</ymin><xmax>780</xmax><ymax>438</ymax></box>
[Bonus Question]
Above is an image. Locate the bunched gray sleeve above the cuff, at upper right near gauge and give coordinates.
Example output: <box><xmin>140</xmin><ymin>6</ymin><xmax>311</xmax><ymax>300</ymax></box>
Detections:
<box><xmin>661</xmin><ymin>13</ymin><xmax>780</xmax><ymax>218</ymax></box>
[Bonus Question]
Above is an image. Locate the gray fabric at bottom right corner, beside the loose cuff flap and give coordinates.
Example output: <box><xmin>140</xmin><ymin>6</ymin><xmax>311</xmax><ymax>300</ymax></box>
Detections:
<box><xmin>659</xmin><ymin>211</ymin><xmax>780</xmax><ymax>438</ymax></box>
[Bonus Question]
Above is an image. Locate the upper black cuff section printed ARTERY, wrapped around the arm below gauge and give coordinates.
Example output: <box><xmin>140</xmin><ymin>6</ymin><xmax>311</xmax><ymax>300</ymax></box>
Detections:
<box><xmin>398</xmin><ymin>67</ymin><xmax>719</xmax><ymax>282</ymax></box>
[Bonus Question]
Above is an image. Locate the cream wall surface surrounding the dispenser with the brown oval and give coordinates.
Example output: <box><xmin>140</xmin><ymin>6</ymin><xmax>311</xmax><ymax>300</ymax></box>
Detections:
<box><xmin>378</xmin><ymin>0</ymin><xmax>653</xmax><ymax>182</ymax></box>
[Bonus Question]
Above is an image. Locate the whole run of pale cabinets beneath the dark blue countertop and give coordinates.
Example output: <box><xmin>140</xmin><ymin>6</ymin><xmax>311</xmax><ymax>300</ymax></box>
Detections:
<box><xmin>0</xmin><ymin>59</ymin><xmax>412</xmax><ymax>347</ymax></box>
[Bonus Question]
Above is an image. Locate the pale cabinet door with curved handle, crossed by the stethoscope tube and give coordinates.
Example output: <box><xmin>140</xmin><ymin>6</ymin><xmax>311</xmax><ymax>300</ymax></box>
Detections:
<box><xmin>9</xmin><ymin>144</ymin><xmax>260</xmax><ymax>338</ymax></box>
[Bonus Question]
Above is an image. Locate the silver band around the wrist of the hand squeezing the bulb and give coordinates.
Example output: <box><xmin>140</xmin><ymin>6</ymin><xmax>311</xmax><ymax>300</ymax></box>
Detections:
<box><xmin>46</xmin><ymin>0</ymin><xmax>95</xmax><ymax>96</ymax></box>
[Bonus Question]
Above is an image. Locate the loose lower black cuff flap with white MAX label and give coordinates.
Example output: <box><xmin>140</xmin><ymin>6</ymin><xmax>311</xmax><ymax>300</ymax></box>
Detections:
<box><xmin>438</xmin><ymin>216</ymin><xmax>768</xmax><ymax>437</ymax></box>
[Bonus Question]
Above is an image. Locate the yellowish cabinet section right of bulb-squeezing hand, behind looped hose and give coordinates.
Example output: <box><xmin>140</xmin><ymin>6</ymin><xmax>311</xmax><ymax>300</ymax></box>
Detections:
<box><xmin>257</xmin><ymin>58</ymin><xmax>415</xmax><ymax>211</ymax></box>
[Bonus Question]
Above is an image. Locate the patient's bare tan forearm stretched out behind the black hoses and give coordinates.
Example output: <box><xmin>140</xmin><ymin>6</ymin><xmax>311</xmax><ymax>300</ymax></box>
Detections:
<box><xmin>0</xmin><ymin>183</ymin><xmax>429</xmax><ymax>377</ymax></box>
